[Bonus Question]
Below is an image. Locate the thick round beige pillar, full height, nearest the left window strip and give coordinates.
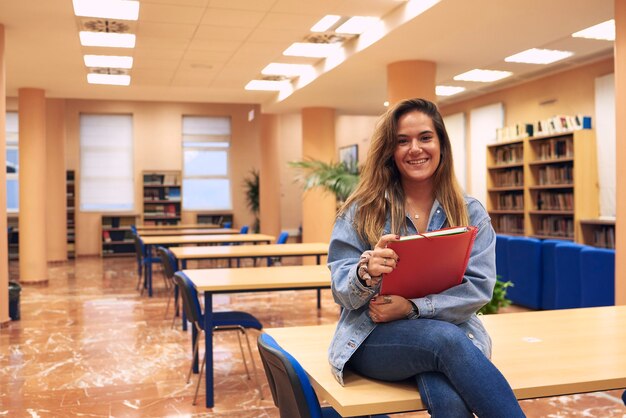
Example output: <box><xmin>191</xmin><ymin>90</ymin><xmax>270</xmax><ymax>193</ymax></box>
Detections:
<box><xmin>18</xmin><ymin>88</ymin><xmax>48</xmax><ymax>283</ymax></box>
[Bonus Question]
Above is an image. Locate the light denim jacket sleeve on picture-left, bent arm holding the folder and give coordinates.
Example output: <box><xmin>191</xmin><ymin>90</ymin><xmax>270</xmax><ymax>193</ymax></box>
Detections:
<box><xmin>328</xmin><ymin>210</ymin><xmax>380</xmax><ymax>310</ymax></box>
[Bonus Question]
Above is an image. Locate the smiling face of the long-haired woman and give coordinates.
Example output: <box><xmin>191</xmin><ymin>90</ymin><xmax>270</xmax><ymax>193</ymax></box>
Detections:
<box><xmin>393</xmin><ymin>110</ymin><xmax>441</xmax><ymax>183</ymax></box>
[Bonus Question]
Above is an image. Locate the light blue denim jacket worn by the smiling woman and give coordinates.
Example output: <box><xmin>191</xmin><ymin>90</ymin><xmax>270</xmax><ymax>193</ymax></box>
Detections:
<box><xmin>328</xmin><ymin>197</ymin><xmax>496</xmax><ymax>385</ymax></box>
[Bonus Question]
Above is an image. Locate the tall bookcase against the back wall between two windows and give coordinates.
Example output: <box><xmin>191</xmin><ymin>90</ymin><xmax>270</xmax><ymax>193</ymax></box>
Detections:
<box><xmin>143</xmin><ymin>171</ymin><xmax>182</xmax><ymax>225</ymax></box>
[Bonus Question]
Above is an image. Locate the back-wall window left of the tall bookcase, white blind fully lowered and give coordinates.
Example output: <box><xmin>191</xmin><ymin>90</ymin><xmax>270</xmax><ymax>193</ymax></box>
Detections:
<box><xmin>80</xmin><ymin>115</ymin><xmax>135</xmax><ymax>212</ymax></box>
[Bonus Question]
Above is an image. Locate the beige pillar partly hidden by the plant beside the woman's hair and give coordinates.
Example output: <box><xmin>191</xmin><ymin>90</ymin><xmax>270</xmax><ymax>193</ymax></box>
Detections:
<box><xmin>302</xmin><ymin>107</ymin><xmax>337</xmax><ymax>250</ymax></box>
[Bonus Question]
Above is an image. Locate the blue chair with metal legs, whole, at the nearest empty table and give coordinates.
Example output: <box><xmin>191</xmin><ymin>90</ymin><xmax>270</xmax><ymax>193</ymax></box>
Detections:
<box><xmin>174</xmin><ymin>272</ymin><xmax>263</xmax><ymax>405</ymax></box>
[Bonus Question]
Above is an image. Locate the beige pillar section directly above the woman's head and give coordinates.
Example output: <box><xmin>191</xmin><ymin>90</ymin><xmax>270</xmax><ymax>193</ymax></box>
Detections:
<box><xmin>387</xmin><ymin>60</ymin><xmax>437</xmax><ymax>104</ymax></box>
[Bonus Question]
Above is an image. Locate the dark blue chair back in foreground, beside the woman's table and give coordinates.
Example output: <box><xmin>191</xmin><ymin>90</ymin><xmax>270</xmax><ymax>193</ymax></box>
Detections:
<box><xmin>257</xmin><ymin>334</ymin><xmax>387</xmax><ymax>418</ymax></box>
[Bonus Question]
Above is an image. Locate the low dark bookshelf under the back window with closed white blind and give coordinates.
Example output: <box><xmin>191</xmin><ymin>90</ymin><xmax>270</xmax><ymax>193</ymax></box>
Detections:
<box><xmin>100</xmin><ymin>215</ymin><xmax>137</xmax><ymax>257</ymax></box>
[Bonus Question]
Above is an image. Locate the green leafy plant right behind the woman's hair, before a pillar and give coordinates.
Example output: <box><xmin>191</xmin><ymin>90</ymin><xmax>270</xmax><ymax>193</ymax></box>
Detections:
<box><xmin>289</xmin><ymin>160</ymin><xmax>359</xmax><ymax>202</ymax></box>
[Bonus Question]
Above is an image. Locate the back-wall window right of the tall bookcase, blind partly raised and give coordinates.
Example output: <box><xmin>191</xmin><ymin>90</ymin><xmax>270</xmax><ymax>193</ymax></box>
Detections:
<box><xmin>183</xmin><ymin>116</ymin><xmax>232</xmax><ymax>210</ymax></box>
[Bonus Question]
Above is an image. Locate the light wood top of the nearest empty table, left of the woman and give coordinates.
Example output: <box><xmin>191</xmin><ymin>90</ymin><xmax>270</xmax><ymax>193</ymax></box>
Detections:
<box><xmin>183</xmin><ymin>265</ymin><xmax>330</xmax><ymax>293</ymax></box>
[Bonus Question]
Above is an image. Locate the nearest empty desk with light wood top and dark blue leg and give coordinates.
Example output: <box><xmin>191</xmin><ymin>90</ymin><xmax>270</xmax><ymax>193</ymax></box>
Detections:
<box><xmin>183</xmin><ymin>265</ymin><xmax>330</xmax><ymax>408</ymax></box>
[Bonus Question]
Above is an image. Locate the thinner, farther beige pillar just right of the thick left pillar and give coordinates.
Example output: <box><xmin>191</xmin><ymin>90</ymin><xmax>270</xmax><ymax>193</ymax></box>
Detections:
<box><xmin>46</xmin><ymin>99</ymin><xmax>67</xmax><ymax>261</ymax></box>
